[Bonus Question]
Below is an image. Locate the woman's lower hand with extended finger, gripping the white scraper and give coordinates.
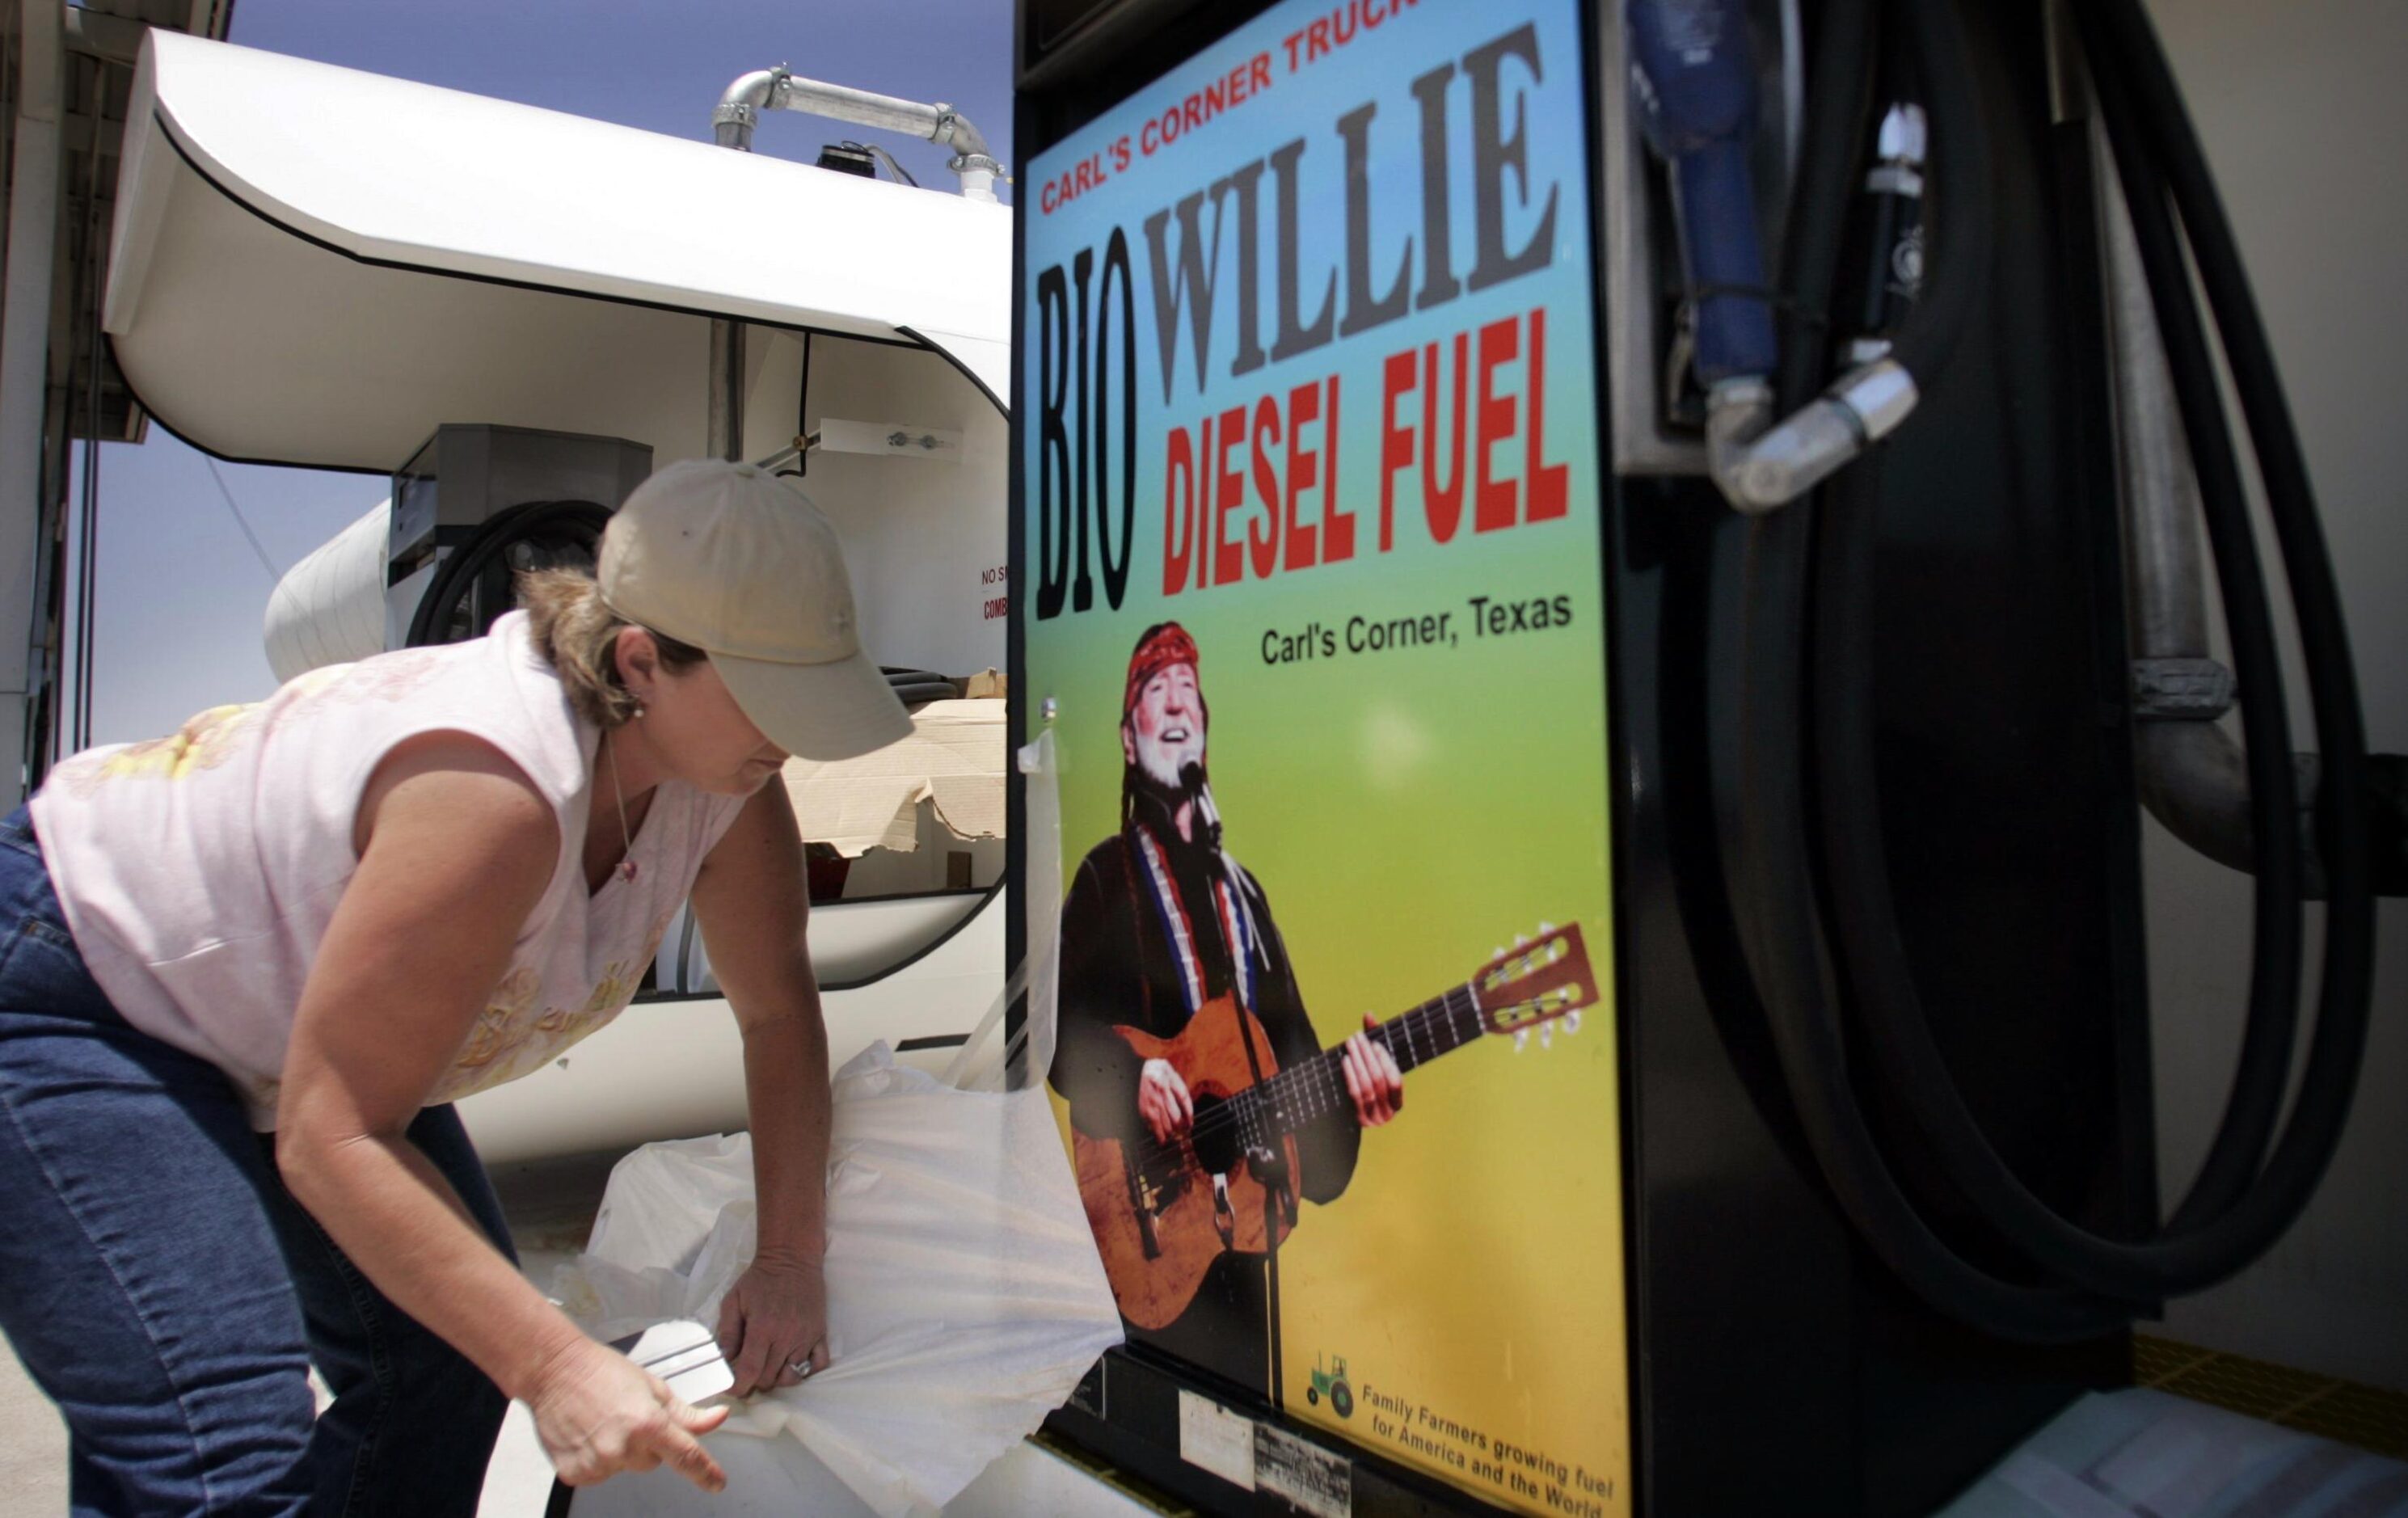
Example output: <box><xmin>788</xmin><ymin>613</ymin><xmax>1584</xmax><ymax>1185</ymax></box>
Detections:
<box><xmin>527</xmin><ymin>1339</ymin><xmax>727</xmax><ymax>1491</ymax></box>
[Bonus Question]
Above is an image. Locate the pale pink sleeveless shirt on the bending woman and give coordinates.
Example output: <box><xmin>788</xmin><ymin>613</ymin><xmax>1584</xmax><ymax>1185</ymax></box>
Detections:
<box><xmin>32</xmin><ymin>612</ymin><xmax>744</xmax><ymax>1130</ymax></box>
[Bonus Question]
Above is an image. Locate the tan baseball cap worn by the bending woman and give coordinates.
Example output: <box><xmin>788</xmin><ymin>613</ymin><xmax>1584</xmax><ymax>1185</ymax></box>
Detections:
<box><xmin>595</xmin><ymin>458</ymin><xmax>910</xmax><ymax>759</ymax></box>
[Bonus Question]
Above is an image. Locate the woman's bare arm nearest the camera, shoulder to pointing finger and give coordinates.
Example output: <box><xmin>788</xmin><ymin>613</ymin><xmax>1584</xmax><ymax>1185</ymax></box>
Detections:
<box><xmin>277</xmin><ymin>732</ymin><xmax>725</xmax><ymax>1489</ymax></box>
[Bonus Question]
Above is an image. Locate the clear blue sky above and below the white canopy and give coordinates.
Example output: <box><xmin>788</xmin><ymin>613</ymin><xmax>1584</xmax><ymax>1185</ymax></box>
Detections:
<box><xmin>70</xmin><ymin>0</ymin><xmax>1011</xmax><ymax>742</ymax></box>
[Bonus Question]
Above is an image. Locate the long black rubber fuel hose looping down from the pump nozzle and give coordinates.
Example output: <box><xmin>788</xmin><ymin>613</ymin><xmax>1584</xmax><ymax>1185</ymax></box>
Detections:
<box><xmin>1734</xmin><ymin>0</ymin><xmax>2374</xmax><ymax>1339</ymax></box>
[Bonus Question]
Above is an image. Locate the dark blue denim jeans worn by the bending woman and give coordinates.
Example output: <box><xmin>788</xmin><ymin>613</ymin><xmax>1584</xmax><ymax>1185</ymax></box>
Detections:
<box><xmin>0</xmin><ymin>807</ymin><xmax>511</xmax><ymax>1518</ymax></box>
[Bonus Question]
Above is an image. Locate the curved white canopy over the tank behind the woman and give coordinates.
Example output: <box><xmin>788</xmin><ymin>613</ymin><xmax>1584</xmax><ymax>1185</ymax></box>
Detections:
<box><xmin>106</xmin><ymin>32</ymin><xmax>1011</xmax><ymax>470</ymax></box>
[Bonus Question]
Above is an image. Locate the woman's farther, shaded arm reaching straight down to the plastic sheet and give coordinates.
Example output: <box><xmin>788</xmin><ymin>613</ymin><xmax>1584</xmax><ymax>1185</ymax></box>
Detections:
<box><xmin>694</xmin><ymin>781</ymin><xmax>829</xmax><ymax>1395</ymax></box>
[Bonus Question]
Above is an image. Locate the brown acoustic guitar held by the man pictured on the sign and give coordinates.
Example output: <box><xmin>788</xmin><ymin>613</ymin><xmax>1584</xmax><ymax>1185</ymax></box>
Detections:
<box><xmin>1072</xmin><ymin>923</ymin><xmax>1596</xmax><ymax>1328</ymax></box>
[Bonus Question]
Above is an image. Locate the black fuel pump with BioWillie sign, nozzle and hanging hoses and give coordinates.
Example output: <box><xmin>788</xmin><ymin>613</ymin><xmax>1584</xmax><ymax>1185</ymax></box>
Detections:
<box><xmin>1011</xmin><ymin>0</ymin><xmax>2408</xmax><ymax>1513</ymax></box>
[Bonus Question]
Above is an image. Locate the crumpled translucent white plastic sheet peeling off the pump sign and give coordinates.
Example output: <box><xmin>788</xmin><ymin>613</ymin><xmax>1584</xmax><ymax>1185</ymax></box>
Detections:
<box><xmin>554</xmin><ymin>742</ymin><xmax>1120</xmax><ymax>1518</ymax></box>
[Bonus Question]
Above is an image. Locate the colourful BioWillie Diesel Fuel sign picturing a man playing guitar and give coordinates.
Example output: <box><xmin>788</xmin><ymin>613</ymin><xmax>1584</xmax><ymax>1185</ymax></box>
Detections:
<box><xmin>1011</xmin><ymin>0</ymin><xmax>1630</xmax><ymax>1513</ymax></box>
